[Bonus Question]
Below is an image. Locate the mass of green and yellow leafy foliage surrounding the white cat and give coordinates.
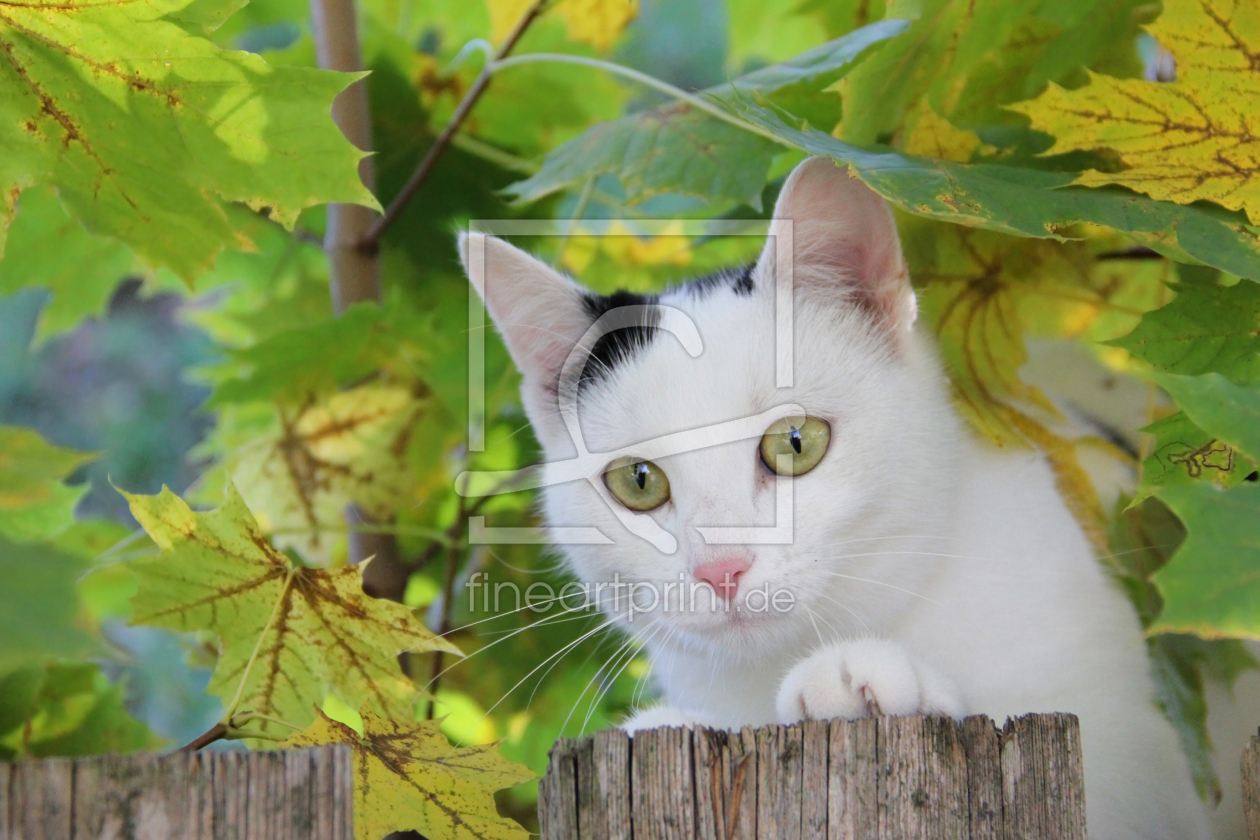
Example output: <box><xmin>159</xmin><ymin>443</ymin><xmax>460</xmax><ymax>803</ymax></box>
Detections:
<box><xmin>7</xmin><ymin>0</ymin><xmax>1260</xmax><ymax>840</ymax></box>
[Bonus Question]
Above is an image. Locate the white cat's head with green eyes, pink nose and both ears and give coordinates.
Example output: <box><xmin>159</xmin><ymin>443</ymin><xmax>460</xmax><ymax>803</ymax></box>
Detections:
<box><xmin>461</xmin><ymin>159</ymin><xmax>955</xmax><ymax>647</ymax></box>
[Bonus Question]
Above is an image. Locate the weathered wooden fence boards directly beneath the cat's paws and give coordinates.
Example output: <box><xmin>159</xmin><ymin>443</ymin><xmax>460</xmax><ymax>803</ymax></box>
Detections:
<box><xmin>538</xmin><ymin>714</ymin><xmax>1083</xmax><ymax>840</ymax></box>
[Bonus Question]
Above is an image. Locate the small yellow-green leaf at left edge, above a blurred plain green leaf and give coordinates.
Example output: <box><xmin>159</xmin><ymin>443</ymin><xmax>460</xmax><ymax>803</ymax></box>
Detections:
<box><xmin>0</xmin><ymin>426</ymin><xmax>97</xmax><ymax>542</ymax></box>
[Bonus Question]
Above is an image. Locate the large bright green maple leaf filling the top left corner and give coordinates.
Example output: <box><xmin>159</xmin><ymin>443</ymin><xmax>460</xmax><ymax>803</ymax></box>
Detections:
<box><xmin>0</xmin><ymin>0</ymin><xmax>377</xmax><ymax>281</ymax></box>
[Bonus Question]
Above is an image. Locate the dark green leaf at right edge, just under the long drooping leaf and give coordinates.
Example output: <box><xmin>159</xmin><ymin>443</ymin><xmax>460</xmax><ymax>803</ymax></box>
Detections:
<box><xmin>1106</xmin><ymin>283</ymin><xmax>1260</xmax><ymax>385</ymax></box>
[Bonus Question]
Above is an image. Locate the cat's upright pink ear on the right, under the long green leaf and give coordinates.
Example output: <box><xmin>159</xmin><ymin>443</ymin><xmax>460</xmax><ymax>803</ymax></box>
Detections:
<box><xmin>757</xmin><ymin>157</ymin><xmax>916</xmax><ymax>330</ymax></box>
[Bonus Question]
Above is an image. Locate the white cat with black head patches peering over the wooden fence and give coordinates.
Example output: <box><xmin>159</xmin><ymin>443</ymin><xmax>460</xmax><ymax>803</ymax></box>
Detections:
<box><xmin>461</xmin><ymin>159</ymin><xmax>1260</xmax><ymax>840</ymax></box>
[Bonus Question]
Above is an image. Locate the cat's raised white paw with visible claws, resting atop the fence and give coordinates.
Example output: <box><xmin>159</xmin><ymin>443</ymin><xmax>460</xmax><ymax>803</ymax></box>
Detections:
<box><xmin>776</xmin><ymin>639</ymin><xmax>966</xmax><ymax>723</ymax></box>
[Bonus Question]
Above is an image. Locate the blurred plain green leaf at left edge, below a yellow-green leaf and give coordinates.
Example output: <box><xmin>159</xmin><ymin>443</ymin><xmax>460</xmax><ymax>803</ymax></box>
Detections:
<box><xmin>0</xmin><ymin>535</ymin><xmax>93</xmax><ymax>673</ymax></box>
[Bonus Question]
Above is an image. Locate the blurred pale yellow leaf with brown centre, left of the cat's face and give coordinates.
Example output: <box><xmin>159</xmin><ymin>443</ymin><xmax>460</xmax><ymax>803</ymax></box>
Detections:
<box><xmin>232</xmin><ymin>385</ymin><xmax>422</xmax><ymax>564</ymax></box>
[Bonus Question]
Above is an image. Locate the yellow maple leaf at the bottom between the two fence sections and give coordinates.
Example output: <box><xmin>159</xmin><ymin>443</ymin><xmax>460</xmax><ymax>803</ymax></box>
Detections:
<box><xmin>281</xmin><ymin>709</ymin><xmax>534</xmax><ymax>840</ymax></box>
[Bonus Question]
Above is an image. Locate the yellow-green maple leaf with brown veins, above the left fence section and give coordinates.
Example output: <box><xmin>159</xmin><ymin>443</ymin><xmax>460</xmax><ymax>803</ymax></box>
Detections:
<box><xmin>123</xmin><ymin>484</ymin><xmax>459</xmax><ymax>733</ymax></box>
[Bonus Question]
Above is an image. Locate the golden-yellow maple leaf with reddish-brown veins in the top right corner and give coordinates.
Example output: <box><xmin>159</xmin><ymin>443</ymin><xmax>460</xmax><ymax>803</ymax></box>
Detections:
<box><xmin>1011</xmin><ymin>0</ymin><xmax>1260</xmax><ymax>224</ymax></box>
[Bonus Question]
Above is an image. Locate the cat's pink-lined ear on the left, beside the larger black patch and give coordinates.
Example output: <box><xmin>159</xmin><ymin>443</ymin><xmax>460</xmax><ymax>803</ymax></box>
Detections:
<box><xmin>459</xmin><ymin>233</ymin><xmax>592</xmax><ymax>427</ymax></box>
